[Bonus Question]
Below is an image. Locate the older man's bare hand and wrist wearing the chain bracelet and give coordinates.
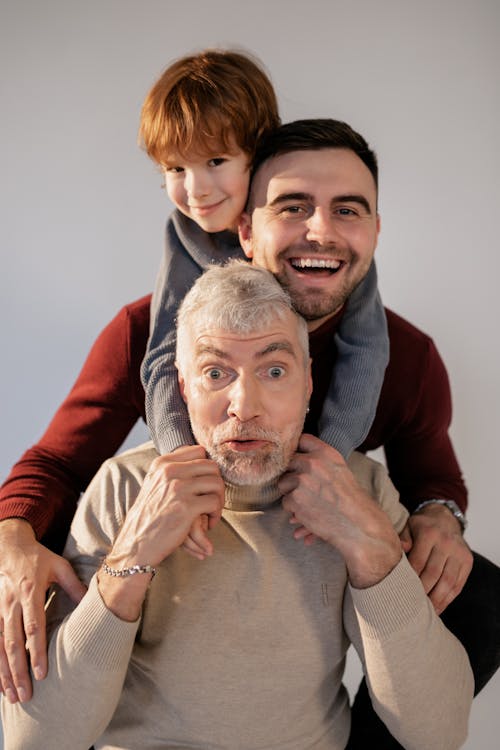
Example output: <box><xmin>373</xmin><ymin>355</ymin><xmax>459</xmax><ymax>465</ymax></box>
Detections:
<box><xmin>98</xmin><ymin>445</ymin><xmax>224</xmax><ymax>621</ymax></box>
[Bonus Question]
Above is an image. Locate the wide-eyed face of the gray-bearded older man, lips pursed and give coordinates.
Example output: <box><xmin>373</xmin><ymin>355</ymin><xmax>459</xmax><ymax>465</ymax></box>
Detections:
<box><xmin>179</xmin><ymin>312</ymin><xmax>312</xmax><ymax>485</ymax></box>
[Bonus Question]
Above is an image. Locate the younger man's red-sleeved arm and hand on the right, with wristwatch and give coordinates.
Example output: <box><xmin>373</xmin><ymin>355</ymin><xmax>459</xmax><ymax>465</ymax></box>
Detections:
<box><xmin>370</xmin><ymin>311</ymin><xmax>472</xmax><ymax>613</ymax></box>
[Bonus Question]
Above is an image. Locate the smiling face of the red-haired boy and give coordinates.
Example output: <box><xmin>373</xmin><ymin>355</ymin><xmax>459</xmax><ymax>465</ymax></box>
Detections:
<box><xmin>165</xmin><ymin>147</ymin><xmax>250</xmax><ymax>232</ymax></box>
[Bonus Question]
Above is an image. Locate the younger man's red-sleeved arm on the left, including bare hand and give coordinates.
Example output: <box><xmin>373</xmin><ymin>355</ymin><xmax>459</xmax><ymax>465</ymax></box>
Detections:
<box><xmin>0</xmin><ymin>298</ymin><xmax>149</xmax><ymax>699</ymax></box>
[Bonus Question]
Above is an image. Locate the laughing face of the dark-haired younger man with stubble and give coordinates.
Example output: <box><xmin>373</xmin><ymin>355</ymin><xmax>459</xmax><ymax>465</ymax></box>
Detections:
<box><xmin>240</xmin><ymin>148</ymin><xmax>380</xmax><ymax>330</ymax></box>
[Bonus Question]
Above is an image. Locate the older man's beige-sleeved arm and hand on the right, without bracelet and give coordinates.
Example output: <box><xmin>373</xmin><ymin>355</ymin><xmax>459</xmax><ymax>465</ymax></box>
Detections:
<box><xmin>280</xmin><ymin>435</ymin><xmax>473</xmax><ymax>750</ymax></box>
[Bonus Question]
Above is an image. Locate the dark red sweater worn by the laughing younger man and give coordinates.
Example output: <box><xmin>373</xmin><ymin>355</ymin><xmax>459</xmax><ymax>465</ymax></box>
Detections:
<box><xmin>0</xmin><ymin>296</ymin><xmax>467</xmax><ymax>551</ymax></box>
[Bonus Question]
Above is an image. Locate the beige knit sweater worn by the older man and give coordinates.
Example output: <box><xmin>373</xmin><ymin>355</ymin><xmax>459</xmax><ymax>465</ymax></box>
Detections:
<box><xmin>2</xmin><ymin>444</ymin><xmax>473</xmax><ymax>750</ymax></box>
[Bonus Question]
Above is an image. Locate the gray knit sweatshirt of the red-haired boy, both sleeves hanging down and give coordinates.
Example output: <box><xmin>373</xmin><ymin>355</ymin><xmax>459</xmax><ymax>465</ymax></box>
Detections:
<box><xmin>141</xmin><ymin>210</ymin><xmax>389</xmax><ymax>458</ymax></box>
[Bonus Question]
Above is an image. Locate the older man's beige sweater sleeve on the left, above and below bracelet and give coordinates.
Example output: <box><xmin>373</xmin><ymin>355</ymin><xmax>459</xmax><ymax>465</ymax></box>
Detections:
<box><xmin>2</xmin><ymin>464</ymin><xmax>139</xmax><ymax>750</ymax></box>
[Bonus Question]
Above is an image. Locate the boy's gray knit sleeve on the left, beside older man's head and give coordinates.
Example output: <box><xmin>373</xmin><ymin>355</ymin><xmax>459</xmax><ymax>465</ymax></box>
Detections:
<box><xmin>141</xmin><ymin>219</ymin><xmax>203</xmax><ymax>453</ymax></box>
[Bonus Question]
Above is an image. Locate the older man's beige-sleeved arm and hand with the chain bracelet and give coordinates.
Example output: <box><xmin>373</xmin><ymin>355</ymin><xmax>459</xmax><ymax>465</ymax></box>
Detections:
<box><xmin>2</xmin><ymin>446</ymin><xmax>224</xmax><ymax>750</ymax></box>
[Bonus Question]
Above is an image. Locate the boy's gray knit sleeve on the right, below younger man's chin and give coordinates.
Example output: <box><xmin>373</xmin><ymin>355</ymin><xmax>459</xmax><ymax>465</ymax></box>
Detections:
<box><xmin>319</xmin><ymin>262</ymin><xmax>389</xmax><ymax>458</ymax></box>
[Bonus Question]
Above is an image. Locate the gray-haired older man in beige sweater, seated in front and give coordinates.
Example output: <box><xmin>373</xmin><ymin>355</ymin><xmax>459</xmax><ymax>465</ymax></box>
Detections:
<box><xmin>3</xmin><ymin>263</ymin><xmax>473</xmax><ymax>750</ymax></box>
